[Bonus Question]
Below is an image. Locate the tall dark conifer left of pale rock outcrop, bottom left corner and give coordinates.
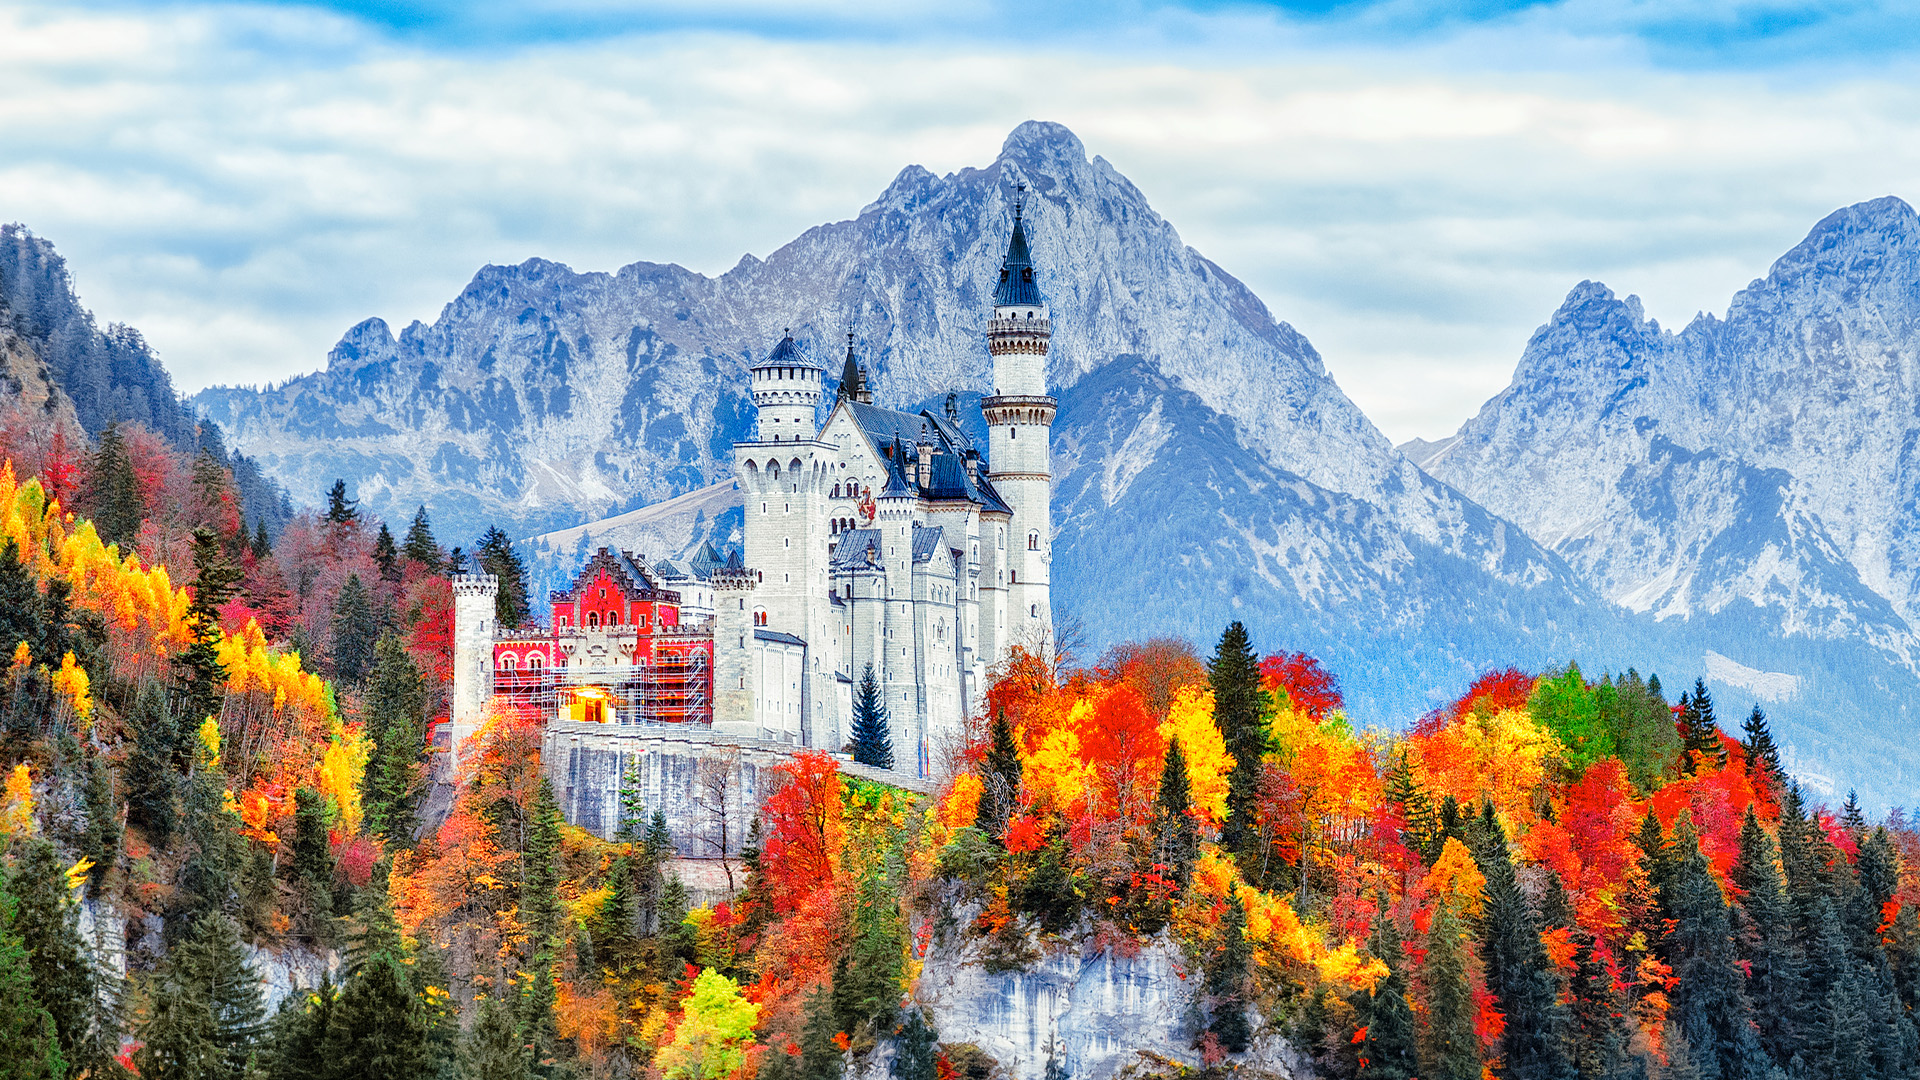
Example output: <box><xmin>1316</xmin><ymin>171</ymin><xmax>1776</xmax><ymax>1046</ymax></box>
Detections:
<box><xmin>10</xmin><ymin>838</ymin><xmax>111</xmax><ymax>1070</ymax></box>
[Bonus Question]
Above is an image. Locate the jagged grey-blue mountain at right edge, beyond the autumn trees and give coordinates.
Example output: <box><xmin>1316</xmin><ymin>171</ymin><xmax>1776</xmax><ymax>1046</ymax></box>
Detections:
<box><xmin>1404</xmin><ymin>198</ymin><xmax>1920</xmax><ymax>794</ymax></box>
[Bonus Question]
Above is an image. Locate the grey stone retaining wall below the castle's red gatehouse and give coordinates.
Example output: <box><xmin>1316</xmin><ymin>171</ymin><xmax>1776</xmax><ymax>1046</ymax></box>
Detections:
<box><xmin>540</xmin><ymin>721</ymin><xmax>931</xmax><ymax>859</ymax></box>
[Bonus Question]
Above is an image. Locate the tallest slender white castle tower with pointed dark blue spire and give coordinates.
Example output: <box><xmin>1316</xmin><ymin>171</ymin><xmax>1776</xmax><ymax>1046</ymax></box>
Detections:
<box><xmin>979</xmin><ymin>194</ymin><xmax>1058</xmax><ymax>659</ymax></box>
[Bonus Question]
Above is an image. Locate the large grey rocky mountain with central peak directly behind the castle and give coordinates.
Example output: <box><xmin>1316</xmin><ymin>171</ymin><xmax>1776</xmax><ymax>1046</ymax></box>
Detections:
<box><xmin>196</xmin><ymin>123</ymin><xmax>1632</xmax><ymax>721</ymax></box>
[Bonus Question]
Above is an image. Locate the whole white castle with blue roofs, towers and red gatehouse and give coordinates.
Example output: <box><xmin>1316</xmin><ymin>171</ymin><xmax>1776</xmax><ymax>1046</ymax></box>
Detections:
<box><xmin>453</xmin><ymin>199</ymin><xmax>1056</xmax><ymax>776</ymax></box>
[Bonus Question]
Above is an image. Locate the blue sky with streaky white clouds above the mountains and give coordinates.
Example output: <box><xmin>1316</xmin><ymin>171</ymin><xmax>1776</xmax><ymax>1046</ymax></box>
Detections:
<box><xmin>0</xmin><ymin>0</ymin><xmax>1920</xmax><ymax>442</ymax></box>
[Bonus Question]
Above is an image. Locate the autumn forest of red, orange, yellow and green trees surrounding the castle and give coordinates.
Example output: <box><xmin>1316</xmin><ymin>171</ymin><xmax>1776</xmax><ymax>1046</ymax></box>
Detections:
<box><xmin>0</xmin><ymin>425</ymin><xmax>1920</xmax><ymax>1080</ymax></box>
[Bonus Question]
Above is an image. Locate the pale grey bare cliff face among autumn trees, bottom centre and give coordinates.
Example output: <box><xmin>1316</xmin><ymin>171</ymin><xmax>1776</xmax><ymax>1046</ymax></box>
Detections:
<box><xmin>914</xmin><ymin>926</ymin><xmax>1198</xmax><ymax>1080</ymax></box>
